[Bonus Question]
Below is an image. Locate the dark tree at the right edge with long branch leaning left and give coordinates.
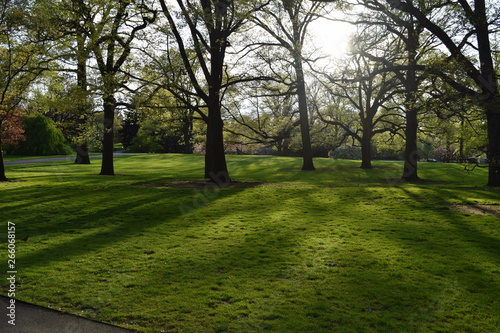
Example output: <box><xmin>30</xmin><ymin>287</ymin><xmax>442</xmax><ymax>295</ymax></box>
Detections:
<box><xmin>388</xmin><ymin>0</ymin><xmax>500</xmax><ymax>187</ymax></box>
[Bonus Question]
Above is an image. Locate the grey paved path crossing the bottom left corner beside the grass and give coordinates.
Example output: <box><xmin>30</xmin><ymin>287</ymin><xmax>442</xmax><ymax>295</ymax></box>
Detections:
<box><xmin>0</xmin><ymin>296</ymin><xmax>138</xmax><ymax>333</ymax></box>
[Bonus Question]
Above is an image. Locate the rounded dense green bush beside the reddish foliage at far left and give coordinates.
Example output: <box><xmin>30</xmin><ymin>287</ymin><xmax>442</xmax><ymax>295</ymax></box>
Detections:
<box><xmin>8</xmin><ymin>115</ymin><xmax>71</xmax><ymax>155</ymax></box>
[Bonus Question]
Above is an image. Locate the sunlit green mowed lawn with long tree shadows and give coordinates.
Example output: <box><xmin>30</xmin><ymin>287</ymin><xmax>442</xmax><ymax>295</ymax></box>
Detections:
<box><xmin>0</xmin><ymin>154</ymin><xmax>500</xmax><ymax>333</ymax></box>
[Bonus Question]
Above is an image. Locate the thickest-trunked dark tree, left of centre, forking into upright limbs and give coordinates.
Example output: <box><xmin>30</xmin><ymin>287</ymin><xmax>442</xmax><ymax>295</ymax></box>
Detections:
<box><xmin>160</xmin><ymin>0</ymin><xmax>268</xmax><ymax>183</ymax></box>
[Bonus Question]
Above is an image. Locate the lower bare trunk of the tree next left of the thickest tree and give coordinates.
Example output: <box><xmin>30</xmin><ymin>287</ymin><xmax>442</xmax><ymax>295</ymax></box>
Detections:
<box><xmin>100</xmin><ymin>96</ymin><xmax>116</xmax><ymax>176</ymax></box>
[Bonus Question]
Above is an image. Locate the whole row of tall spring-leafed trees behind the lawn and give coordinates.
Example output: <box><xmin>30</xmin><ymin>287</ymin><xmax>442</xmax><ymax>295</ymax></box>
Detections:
<box><xmin>0</xmin><ymin>0</ymin><xmax>500</xmax><ymax>186</ymax></box>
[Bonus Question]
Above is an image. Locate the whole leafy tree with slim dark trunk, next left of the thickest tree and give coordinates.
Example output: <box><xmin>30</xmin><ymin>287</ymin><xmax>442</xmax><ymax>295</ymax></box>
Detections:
<box><xmin>67</xmin><ymin>0</ymin><xmax>156</xmax><ymax>175</ymax></box>
